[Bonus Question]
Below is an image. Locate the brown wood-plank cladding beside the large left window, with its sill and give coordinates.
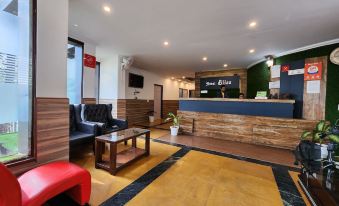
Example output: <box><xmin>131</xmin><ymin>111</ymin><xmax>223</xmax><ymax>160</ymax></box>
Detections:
<box><xmin>10</xmin><ymin>97</ymin><xmax>69</xmax><ymax>174</ymax></box>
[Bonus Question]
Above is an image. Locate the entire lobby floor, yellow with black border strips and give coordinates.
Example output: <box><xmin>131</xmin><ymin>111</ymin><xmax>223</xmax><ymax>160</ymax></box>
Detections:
<box><xmin>59</xmin><ymin>129</ymin><xmax>309</xmax><ymax>206</ymax></box>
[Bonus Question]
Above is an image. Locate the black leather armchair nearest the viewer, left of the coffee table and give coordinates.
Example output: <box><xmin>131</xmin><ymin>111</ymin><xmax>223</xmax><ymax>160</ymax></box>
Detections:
<box><xmin>69</xmin><ymin>105</ymin><xmax>98</xmax><ymax>147</ymax></box>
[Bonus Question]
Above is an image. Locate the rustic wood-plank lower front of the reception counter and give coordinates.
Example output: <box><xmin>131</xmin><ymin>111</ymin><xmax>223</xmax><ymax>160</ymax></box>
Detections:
<box><xmin>178</xmin><ymin>111</ymin><xmax>317</xmax><ymax>149</ymax></box>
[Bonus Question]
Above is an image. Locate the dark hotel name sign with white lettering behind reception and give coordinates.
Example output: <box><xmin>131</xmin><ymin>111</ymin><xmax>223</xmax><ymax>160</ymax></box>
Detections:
<box><xmin>200</xmin><ymin>76</ymin><xmax>240</xmax><ymax>90</ymax></box>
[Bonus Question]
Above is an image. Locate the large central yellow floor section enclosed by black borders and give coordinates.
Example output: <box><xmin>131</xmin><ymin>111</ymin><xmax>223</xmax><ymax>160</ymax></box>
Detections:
<box><xmin>127</xmin><ymin>151</ymin><xmax>282</xmax><ymax>206</ymax></box>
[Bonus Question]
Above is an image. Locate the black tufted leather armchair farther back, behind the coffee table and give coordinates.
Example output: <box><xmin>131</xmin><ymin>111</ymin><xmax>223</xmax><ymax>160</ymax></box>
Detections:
<box><xmin>81</xmin><ymin>104</ymin><xmax>128</xmax><ymax>135</ymax></box>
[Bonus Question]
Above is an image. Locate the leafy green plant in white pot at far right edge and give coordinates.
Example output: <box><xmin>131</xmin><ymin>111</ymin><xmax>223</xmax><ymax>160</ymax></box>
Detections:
<box><xmin>301</xmin><ymin>120</ymin><xmax>339</xmax><ymax>159</ymax></box>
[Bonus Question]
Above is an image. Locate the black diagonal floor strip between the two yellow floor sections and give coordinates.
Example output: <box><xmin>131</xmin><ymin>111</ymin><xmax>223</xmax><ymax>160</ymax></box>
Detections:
<box><xmin>101</xmin><ymin>147</ymin><xmax>190</xmax><ymax>206</ymax></box>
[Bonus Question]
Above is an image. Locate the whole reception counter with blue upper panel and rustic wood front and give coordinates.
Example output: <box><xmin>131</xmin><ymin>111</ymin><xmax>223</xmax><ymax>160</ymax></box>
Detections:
<box><xmin>178</xmin><ymin>98</ymin><xmax>316</xmax><ymax>149</ymax></box>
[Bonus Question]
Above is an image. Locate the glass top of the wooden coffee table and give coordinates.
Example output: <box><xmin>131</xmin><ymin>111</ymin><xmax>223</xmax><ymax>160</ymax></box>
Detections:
<box><xmin>96</xmin><ymin>128</ymin><xmax>150</xmax><ymax>142</ymax></box>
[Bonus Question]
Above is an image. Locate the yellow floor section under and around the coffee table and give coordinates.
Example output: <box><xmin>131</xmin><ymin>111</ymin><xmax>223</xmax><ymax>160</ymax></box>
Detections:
<box><xmin>71</xmin><ymin>139</ymin><xmax>179</xmax><ymax>205</ymax></box>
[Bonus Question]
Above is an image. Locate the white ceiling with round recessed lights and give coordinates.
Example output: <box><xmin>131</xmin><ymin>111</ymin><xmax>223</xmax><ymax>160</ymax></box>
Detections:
<box><xmin>69</xmin><ymin>0</ymin><xmax>339</xmax><ymax>75</ymax></box>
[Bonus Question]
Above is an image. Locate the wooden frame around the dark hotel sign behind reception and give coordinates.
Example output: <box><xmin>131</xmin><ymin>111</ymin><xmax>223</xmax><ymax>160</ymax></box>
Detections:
<box><xmin>195</xmin><ymin>69</ymin><xmax>247</xmax><ymax>97</ymax></box>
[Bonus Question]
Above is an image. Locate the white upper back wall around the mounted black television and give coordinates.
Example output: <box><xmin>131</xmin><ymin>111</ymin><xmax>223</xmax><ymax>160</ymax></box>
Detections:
<box><xmin>124</xmin><ymin>68</ymin><xmax>194</xmax><ymax>100</ymax></box>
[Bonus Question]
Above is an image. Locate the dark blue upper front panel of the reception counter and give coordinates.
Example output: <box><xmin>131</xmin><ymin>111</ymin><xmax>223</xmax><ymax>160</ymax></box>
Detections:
<box><xmin>179</xmin><ymin>98</ymin><xmax>295</xmax><ymax>118</ymax></box>
